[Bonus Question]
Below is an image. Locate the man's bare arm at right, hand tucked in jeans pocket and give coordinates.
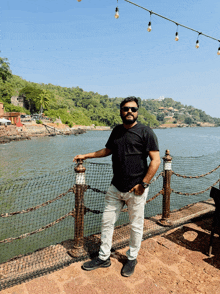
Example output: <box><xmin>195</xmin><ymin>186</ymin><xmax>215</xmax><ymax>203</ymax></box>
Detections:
<box><xmin>129</xmin><ymin>151</ymin><xmax>160</xmax><ymax>195</ymax></box>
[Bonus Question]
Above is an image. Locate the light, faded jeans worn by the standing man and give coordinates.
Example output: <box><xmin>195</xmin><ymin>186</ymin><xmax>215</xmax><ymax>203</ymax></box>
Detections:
<box><xmin>99</xmin><ymin>185</ymin><xmax>149</xmax><ymax>260</ymax></box>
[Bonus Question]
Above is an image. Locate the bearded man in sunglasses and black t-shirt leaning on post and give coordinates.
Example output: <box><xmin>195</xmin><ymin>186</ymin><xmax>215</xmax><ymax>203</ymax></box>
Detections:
<box><xmin>73</xmin><ymin>97</ymin><xmax>160</xmax><ymax>277</ymax></box>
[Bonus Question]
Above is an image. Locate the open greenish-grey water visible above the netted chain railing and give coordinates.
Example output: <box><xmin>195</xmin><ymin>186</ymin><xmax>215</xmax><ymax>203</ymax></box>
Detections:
<box><xmin>0</xmin><ymin>127</ymin><xmax>220</xmax><ymax>181</ymax></box>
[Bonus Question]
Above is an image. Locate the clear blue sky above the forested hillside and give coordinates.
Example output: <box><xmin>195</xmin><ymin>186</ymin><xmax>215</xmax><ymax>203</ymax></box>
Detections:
<box><xmin>0</xmin><ymin>0</ymin><xmax>220</xmax><ymax>117</ymax></box>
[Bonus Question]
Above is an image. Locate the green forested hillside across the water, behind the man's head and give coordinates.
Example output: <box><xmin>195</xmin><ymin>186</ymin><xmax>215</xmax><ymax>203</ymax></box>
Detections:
<box><xmin>0</xmin><ymin>58</ymin><xmax>220</xmax><ymax>127</ymax></box>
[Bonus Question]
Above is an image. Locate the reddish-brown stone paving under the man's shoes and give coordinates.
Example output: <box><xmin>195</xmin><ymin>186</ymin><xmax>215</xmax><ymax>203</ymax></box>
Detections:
<box><xmin>1</xmin><ymin>216</ymin><xmax>220</xmax><ymax>294</ymax></box>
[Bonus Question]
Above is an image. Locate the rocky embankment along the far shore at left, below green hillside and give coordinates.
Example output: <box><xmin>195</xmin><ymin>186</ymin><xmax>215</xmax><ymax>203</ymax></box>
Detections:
<box><xmin>0</xmin><ymin>123</ymin><xmax>86</xmax><ymax>144</ymax></box>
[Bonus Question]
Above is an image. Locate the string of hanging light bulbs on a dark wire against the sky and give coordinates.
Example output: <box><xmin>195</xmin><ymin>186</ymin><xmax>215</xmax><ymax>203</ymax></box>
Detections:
<box><xmin>124</xmin><ymin>0</ymin><xmax>220</xmax><ymax>55</ymax></box>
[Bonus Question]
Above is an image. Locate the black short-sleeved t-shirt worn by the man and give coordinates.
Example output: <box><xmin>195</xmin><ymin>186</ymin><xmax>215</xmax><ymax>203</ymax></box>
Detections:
<box><xmin>105</xmin><ymin>123</ymin><xmax>159</xmax><ymax>192</ymax></box>
